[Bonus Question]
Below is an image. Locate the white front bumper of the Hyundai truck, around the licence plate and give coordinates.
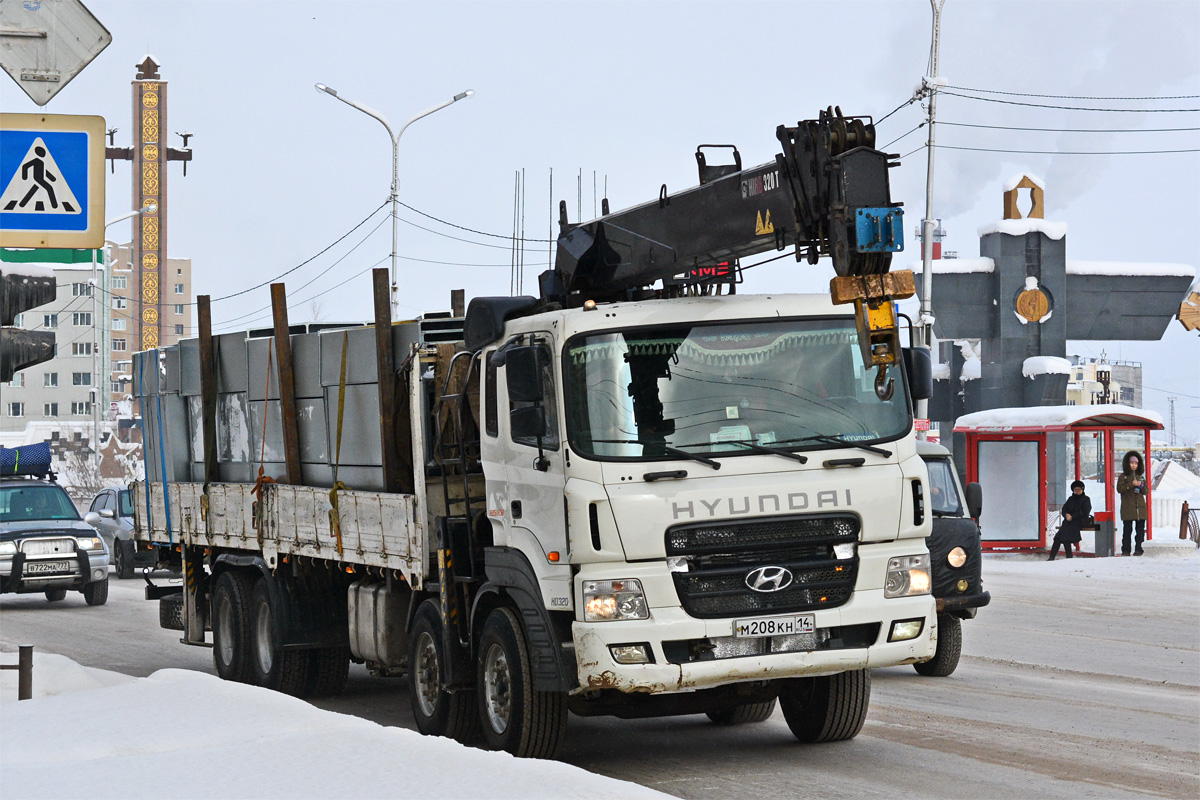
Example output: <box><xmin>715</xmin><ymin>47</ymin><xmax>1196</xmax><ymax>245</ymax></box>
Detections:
<box><xmin>572</xmin><ymin>589</ymin><xmax>937</xmax><ymax>693</ymax></box>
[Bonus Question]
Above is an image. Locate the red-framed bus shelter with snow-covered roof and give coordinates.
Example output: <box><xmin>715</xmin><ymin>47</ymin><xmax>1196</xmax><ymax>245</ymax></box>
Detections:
<box><xmin>954</xmin><ymin>404</ymin><xmax>1163</xmax><ymax>555</ymax></box>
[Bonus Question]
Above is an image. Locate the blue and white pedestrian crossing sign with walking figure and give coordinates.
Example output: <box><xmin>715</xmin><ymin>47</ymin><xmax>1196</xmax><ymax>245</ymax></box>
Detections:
<box><xmin>0</xmin><ymin>114</ymin><xmax>104</xmax><ymax>248</ymax></box>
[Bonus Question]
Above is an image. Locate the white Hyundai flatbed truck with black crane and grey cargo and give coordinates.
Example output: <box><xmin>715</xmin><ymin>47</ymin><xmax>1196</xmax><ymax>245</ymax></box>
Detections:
<box><xmin>134</xmin><ymin>113</ymin><xmax>937</xmax><ymax>758</ymax></box>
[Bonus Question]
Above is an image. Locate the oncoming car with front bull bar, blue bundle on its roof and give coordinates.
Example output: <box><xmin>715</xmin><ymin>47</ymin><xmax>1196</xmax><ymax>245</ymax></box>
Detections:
<box><xmin>0</xmin><ymin>477</ymin><xmax>108</xmax><ymax>606</ymax></box>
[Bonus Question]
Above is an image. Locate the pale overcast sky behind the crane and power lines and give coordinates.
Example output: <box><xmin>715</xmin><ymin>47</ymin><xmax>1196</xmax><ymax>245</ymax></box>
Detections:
<box><xmin>7</xmin><ymin>0</ymin><xmax>1200</xmax><ymax>441</ymax></box>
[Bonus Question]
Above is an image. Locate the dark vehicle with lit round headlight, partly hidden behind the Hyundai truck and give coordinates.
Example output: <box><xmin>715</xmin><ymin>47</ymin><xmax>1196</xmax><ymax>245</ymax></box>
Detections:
<box><xmin>913</xmin><ymin>441</ymin><xmax>991</xmax><ymax>678</ymax></box>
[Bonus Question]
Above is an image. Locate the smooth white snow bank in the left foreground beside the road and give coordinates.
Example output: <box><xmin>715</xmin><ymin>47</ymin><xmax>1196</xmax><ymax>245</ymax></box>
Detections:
<box><xmin>0</xmin><ymin>651</ymin><xmax>670</xmax><ymax>800</ymax></box>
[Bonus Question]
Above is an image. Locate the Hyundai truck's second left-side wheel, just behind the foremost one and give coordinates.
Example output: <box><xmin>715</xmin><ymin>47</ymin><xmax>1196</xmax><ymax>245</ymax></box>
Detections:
<box><xmin>408</xmin><ymin>600</ymin><xmax>479</xmax><ymax>744</ymax></box>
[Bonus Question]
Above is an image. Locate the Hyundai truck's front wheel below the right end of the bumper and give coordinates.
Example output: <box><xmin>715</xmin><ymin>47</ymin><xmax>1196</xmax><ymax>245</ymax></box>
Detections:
<box><xmin>779</xmin><ymin>669</ymin><xmax>871</xmax><ymax>742</ymax></box>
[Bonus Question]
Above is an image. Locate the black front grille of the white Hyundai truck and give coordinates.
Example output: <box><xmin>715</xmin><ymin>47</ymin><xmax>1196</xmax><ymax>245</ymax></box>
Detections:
<box><xmin>666</xmin><ymin>515</ymin><xmax>860</xmax><ymax>618</ymax></box>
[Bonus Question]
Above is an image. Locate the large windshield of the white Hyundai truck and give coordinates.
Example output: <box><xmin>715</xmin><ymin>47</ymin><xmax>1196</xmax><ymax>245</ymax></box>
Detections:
<box><xmin>564</xmin><ymin>319</ymin><xmax>911</xmax><ymax>461</ymax></box>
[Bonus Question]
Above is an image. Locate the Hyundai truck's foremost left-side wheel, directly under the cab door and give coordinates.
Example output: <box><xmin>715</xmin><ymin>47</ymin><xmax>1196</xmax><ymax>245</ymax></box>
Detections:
<box><xmin>476</xmin><ymin>608</ymin><xmax>566</xmax><ymax>758</ymax></box>
